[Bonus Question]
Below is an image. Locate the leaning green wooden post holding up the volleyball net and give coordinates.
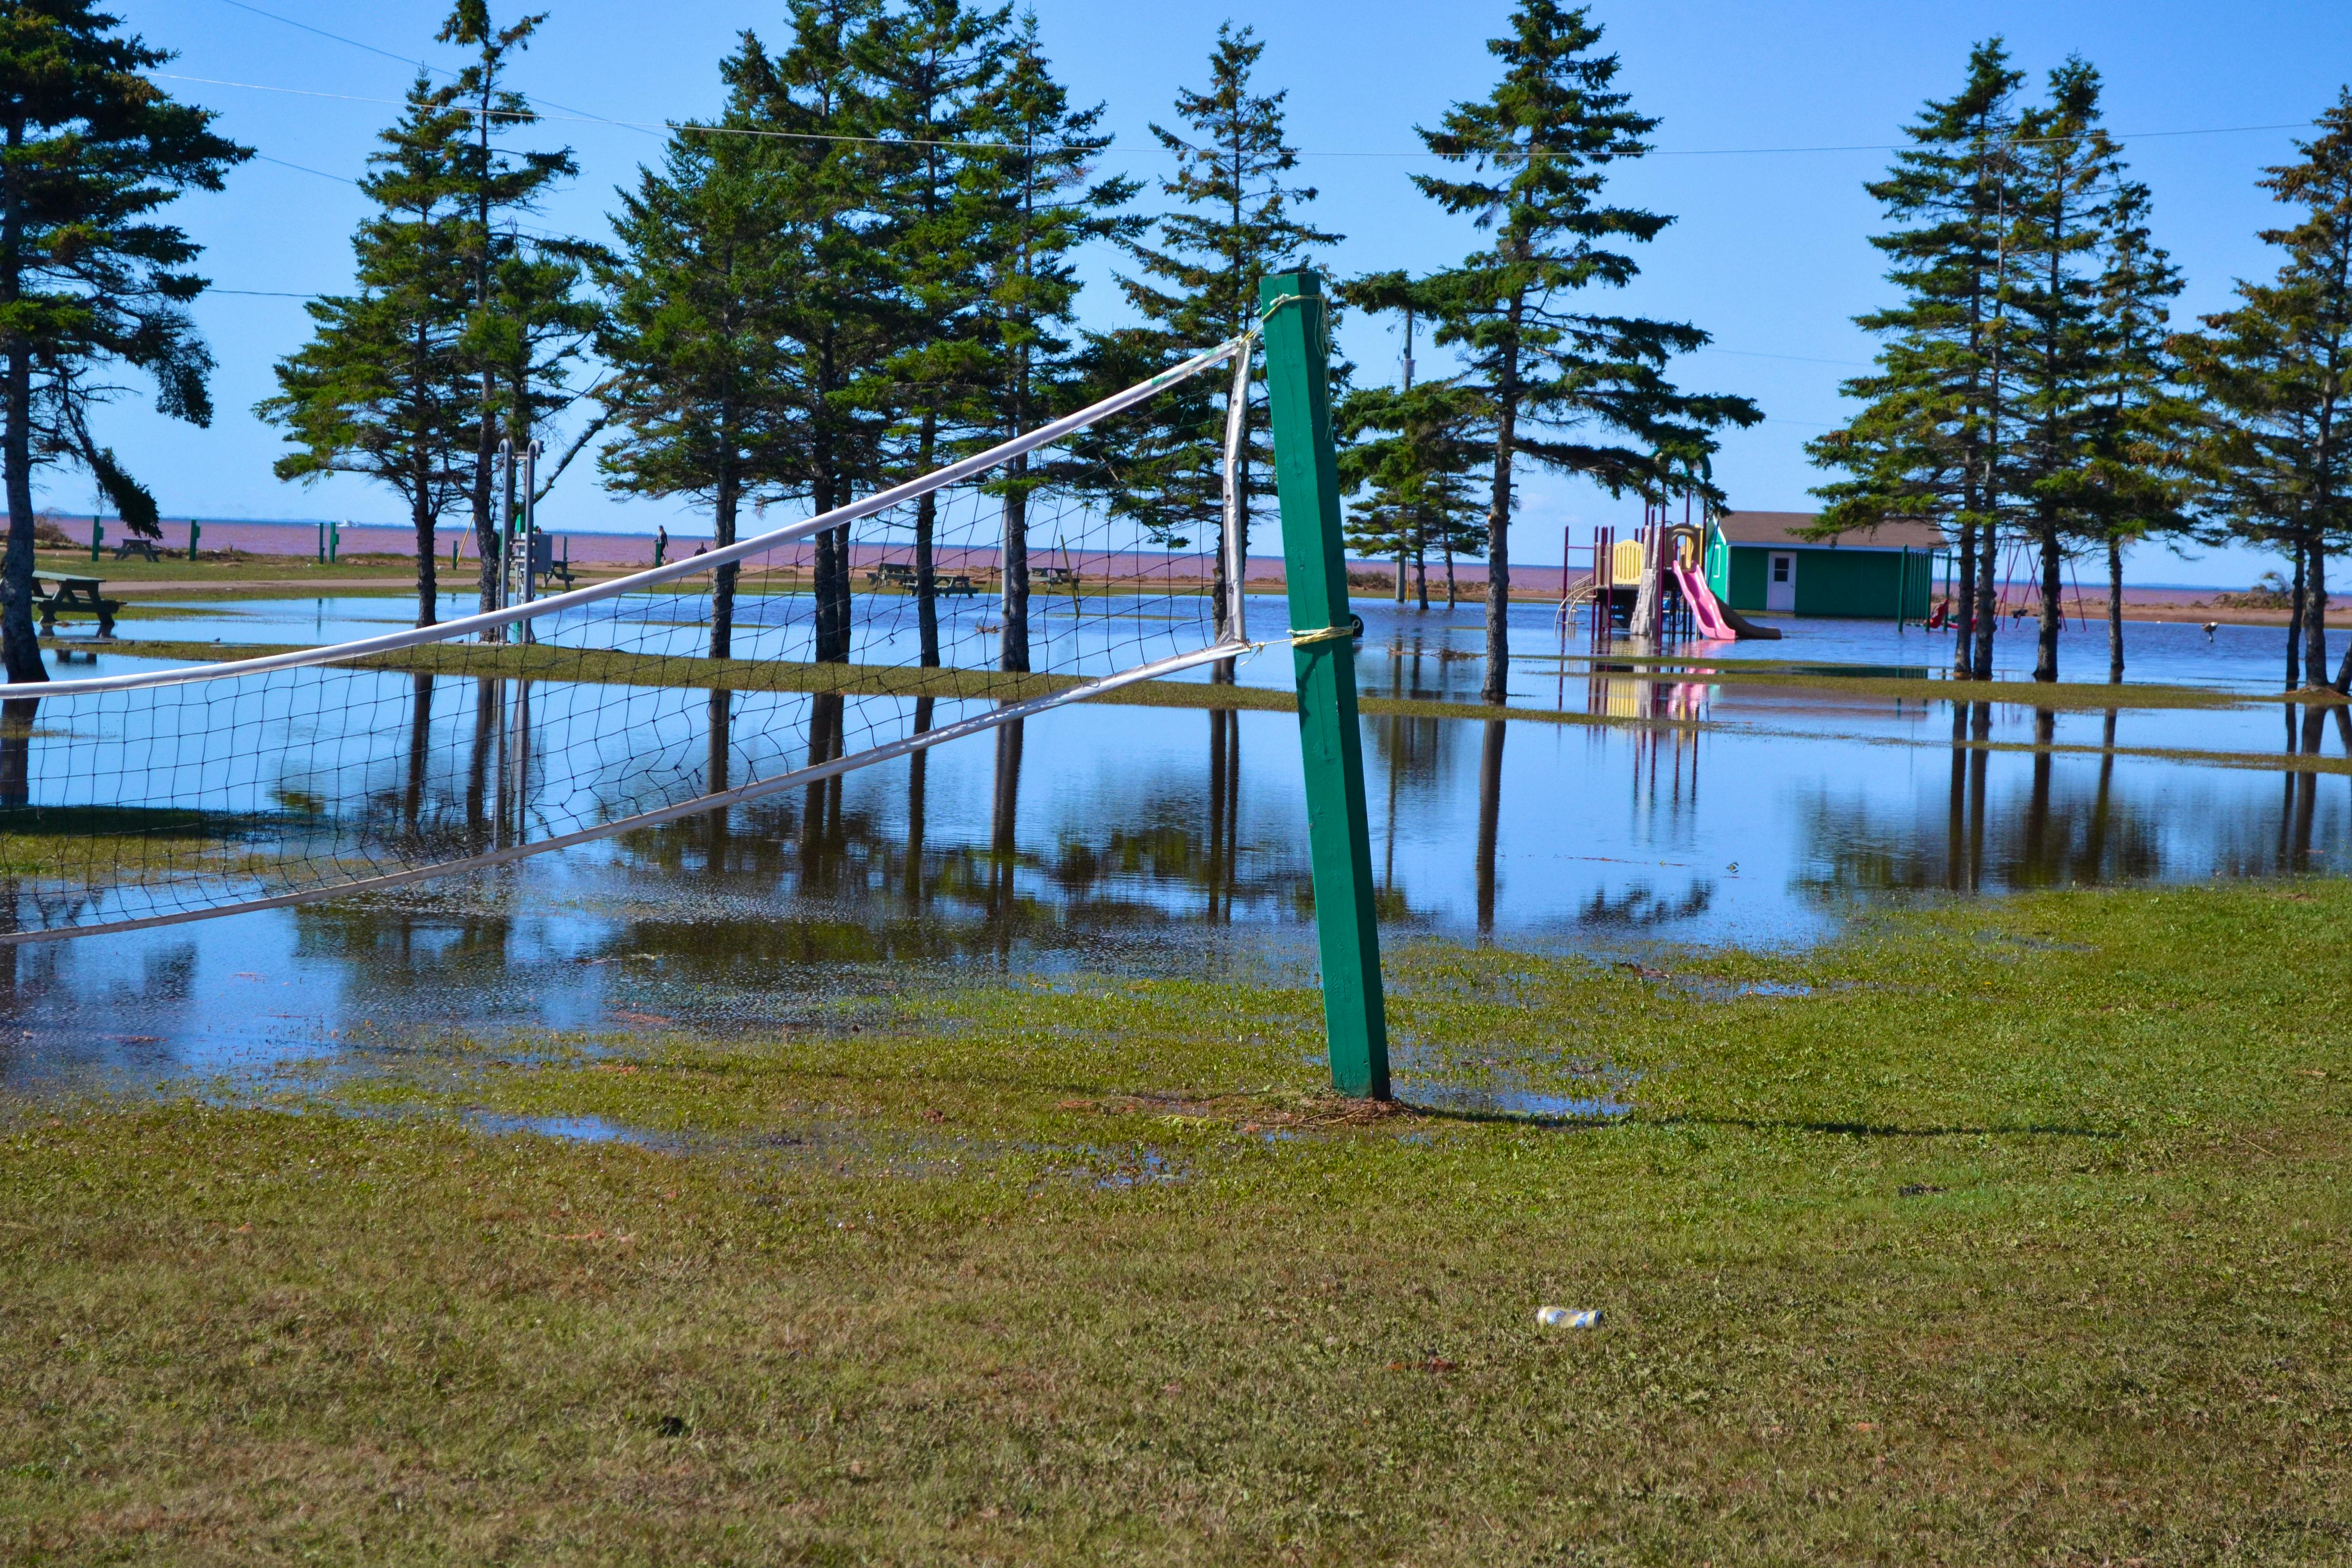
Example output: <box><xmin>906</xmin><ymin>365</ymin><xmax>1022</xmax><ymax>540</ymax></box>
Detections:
<box><xmin>1258</xmin><ymin>273</ymin><xmax>1388</xmax><ymax>1100</ymax></box>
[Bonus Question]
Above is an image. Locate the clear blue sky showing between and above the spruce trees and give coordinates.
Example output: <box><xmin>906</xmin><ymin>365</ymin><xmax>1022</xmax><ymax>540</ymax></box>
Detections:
<box><xmin>91</xmin><ymin>0</ymin><xmax>2352</xmax><ymax>583</ymax></box>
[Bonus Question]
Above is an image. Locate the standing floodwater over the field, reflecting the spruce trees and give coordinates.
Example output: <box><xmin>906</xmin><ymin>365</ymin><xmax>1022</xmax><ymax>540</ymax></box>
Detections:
<box><xmin>0</xmin><ymin>597</ymin><xmax>2352</xmax><ymax>1093</ymax></box>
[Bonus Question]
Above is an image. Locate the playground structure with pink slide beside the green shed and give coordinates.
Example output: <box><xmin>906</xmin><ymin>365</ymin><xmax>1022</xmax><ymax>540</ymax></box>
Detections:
<box><xmin>1555</xmin><ymin>501</ymin><xmax>1780</xmax><ymax>653</ymax></box>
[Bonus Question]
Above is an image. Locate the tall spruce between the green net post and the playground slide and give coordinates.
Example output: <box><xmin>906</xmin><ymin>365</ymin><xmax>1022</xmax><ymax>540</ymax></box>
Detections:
<box><xmin>1413</xmin><ymin>0</ymin><xmax>1761</xmax><ymax>703</ymax></box>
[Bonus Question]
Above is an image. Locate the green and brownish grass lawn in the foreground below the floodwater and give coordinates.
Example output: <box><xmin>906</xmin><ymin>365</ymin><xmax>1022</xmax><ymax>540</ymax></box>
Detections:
<box><xmin>0</xmin><ymin>881</ymin><xmax>2352</xmax><ymax>1565</ymax></box>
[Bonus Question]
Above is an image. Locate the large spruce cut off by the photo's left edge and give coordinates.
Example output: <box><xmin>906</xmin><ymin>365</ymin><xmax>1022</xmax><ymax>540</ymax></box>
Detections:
<box><xmin>0</xmin><ymin>0</ymin><xmax>252</xmax><ymax>682</ymax></box>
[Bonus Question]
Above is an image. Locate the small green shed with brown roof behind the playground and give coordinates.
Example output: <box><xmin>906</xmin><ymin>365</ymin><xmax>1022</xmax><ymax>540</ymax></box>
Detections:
<box><xmin>1707</xmin><ymin>512</ymin><xmax>1950</xmax><ymax>621</ymax></box>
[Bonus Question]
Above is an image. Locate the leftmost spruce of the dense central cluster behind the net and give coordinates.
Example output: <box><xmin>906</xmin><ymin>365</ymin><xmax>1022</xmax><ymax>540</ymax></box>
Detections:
<box><xmin>597</xmin><ymin>35</ymin><xmax>797</xmax><ymax>658</ymax></box>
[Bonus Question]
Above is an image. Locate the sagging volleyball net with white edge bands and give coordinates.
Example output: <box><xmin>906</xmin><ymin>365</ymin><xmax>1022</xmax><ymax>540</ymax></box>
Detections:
<box><xmin>0</xmin><ymin>334</ymin><xmax>1256</xmax><ymax>943</ymax></box>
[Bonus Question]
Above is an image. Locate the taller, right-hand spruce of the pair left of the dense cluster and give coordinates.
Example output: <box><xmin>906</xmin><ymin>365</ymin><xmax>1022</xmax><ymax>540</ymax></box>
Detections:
<box><xmin>435</xmin><ymin>0</ymin><xmax>579</xmax><ymax>609</ymax></box>
